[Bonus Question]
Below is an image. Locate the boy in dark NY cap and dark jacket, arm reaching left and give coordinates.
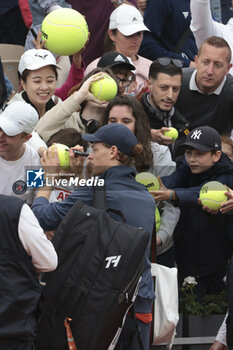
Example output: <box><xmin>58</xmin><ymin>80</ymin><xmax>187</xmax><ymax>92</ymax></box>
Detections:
<box><xmin>153</xmin><ymin>126</ymin><xmax>233</xmax><ymax>297</ymax></box>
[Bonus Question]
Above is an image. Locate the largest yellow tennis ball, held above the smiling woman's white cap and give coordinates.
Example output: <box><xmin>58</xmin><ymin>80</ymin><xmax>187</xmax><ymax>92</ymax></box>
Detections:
<box><xmin>41</xmin><ymin>8</ymin><xmax>88</xmax><ymax>56</ymax></box>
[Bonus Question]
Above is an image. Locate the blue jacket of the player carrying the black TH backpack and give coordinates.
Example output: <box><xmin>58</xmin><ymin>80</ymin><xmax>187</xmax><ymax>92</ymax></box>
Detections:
<box><xmin>32</xmin><ymin>166</ymin><xmax>155</xmax><ymax>313</ymax></box>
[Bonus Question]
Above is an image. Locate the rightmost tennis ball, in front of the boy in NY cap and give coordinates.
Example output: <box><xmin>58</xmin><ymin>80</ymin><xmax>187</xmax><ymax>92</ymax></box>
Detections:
<box><xmin>199</xmin><ymin>181</ymin><xmax>227</xmax><ymax>210</ymax></box>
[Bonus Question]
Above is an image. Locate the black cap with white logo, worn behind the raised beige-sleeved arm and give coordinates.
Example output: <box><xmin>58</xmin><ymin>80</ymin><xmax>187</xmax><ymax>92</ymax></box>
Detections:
<box><xmin>97</xmin><ymin>52</ymin><xmax>136</xmax><ymax>70</ymax></box>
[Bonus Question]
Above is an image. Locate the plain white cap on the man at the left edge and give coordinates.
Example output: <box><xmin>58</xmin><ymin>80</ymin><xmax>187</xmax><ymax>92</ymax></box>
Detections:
<box><xmin>0</xmin><ymin>101</ymin><xmax>39</xmax><ymax>136</ymax></box>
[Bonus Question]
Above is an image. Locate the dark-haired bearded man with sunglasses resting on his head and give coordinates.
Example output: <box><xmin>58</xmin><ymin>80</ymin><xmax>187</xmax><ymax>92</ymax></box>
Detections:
<box><xmin>141</xmin><ymin>57</ymin><xmax>189</xmax><ymax>157</ymax></box>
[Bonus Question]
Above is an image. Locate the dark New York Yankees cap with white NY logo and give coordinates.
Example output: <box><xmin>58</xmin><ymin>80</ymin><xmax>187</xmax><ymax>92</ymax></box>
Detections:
<box><xmin>181</xmin><ymin>126</ymin><xmax>222</xmax><ymax>152</ymax></box>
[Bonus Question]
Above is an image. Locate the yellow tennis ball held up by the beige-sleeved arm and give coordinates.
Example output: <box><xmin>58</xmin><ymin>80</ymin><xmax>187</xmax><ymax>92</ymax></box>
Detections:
<box><xmin>90</xmin><ymin>75</ymin><xmax>117</xmax><ymax>101</ymax></box>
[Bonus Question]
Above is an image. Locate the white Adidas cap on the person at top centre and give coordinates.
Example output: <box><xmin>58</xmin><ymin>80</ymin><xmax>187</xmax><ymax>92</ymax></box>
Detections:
<box><xmin>109</xmin><ymin>4</ymin><xmax>149</xmax><ymax>36</ymax></box>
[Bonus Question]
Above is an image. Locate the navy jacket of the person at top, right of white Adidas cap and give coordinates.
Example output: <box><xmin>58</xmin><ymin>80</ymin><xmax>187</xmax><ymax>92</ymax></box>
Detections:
<box><xmin>139</xmin><ymin>0</ymin><xmax>197</xmax><ymax>67</ymax></box>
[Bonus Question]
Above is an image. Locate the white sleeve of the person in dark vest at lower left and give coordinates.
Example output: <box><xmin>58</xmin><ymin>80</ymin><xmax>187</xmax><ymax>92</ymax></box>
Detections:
<box><xmin>18</xmin><ymin>204</ymin><xmax>57</xmax><ymax>272</ymax></box>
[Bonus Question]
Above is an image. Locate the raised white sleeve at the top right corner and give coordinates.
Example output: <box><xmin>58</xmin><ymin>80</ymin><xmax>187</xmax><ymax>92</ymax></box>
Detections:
<box><xmin>190</xmin><ymin>0</ymin><xmax>222</xmax><ymax>48</ymax></box>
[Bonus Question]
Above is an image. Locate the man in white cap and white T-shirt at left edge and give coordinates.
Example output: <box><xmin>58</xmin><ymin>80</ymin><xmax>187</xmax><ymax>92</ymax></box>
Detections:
<box><xmin>0</xmin><ymin>101</ymin><xmax>40</xmax><ymax>204</ymax></box>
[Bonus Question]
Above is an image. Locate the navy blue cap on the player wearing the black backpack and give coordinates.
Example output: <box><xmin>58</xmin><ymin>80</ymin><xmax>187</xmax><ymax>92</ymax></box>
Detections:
<box><xmin>82</xmin><ymin>123</ymin><xmax>138</xmax><ymax>156</ymax></box>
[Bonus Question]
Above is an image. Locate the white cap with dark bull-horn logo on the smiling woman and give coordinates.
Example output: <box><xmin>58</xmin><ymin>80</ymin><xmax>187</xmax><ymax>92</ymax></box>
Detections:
<box><xmin>18</xmin><ymin>49</ymin><xmax>61</xmax><ymax>75</ymax></box>
